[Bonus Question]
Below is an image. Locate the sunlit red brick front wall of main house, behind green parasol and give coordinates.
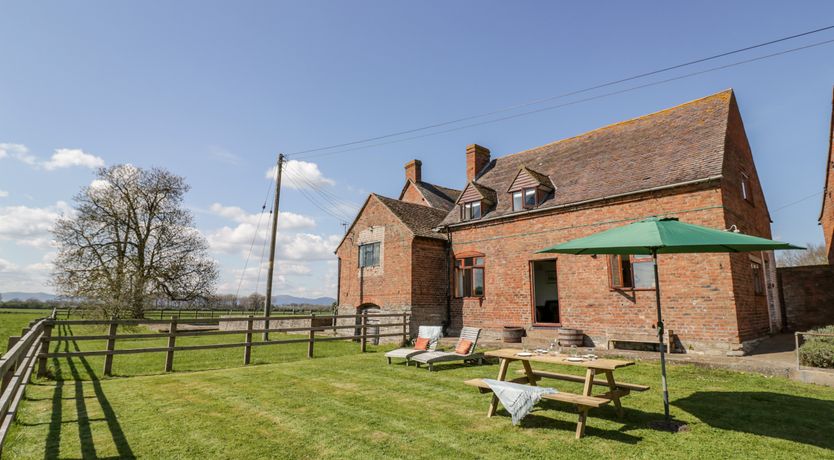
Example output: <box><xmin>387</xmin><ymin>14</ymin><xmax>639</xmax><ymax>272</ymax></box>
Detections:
<box><xmin>452</xmin><ymin>187</ymin><xmax>752</xmax><ymax>349</ymax></box>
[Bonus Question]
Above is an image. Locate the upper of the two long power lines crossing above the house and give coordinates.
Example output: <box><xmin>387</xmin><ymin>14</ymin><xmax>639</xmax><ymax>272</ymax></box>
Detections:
<box><xmin>291</xmin><ymin>25</ymin><xmax>834</xmax><ymax>157</ymax></box>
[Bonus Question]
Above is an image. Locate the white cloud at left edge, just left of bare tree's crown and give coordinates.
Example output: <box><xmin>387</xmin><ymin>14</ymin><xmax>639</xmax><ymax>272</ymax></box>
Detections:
<box><xmin>0</xmin><ymin>201</ymin><xmax>74</xmax><ymax>248</ymax></box>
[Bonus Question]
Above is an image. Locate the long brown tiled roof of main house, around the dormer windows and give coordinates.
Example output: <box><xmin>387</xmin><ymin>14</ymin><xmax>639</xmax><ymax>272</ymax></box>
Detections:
<box><xmin>441</xmin><ymin>90</ymin><xmax>736</xmax><ymax>225</ymax></box>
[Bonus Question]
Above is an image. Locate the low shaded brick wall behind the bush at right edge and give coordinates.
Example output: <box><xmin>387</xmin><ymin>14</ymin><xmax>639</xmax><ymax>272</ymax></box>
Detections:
<box><xmin>777</xmin><ymin>265</ymin><xmax>834</xmax><ymax>331</ymax></box>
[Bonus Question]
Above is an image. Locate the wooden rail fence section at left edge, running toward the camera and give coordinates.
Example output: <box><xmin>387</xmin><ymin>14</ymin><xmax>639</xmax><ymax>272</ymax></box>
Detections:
<box><xmin>0</xmin><ymin>310</ymin><xmax>55</xmax><ymax>454</ymax></box>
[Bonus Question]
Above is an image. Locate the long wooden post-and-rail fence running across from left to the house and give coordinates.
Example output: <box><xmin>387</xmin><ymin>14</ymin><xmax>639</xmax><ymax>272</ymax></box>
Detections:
<box><xmin>37</xmin><ymin>313</ymin><xmax>409</xmax><ymax>377</ymax></box>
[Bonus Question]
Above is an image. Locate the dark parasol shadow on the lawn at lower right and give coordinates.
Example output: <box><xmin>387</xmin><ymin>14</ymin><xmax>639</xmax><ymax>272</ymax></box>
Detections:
<box><xmin>672</xmin><ymin>391</ymin><xmax>834</xmax><ymax>449</ymax></box>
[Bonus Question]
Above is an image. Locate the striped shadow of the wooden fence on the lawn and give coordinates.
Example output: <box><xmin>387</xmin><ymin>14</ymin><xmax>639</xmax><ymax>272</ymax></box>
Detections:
<box><xmin>44</xmin><ymin>326</ymin><xmax>136</xmax><ymax>459</ymax></box>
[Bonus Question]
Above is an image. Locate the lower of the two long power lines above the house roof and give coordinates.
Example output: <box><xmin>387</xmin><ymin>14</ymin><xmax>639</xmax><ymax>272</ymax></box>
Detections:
<box><xmin>298</xmin><ymin>39</ymin><xmax>834</xmax><ymax>158</ymax></box>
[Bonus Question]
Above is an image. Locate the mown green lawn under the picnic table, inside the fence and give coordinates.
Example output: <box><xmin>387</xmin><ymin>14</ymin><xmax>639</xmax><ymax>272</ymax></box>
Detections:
<box><xmin>4</xmin><ymin>343</ymin><xmax>834</xmax><ymax>459</ymax></box>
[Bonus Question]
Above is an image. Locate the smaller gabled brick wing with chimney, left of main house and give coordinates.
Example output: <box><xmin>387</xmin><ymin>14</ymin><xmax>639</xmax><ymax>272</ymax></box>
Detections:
<box><xmin>336</xmin><ymin>160</ymin><xmax>460</xmax><ymax>330</ymax></box>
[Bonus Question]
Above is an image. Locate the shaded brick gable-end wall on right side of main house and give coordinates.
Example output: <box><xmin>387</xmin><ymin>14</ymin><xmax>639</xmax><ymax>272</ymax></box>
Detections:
<box><xmin>722</xmin><ymin>97</ymin><xmax>777</xmax><ymax>341</ymax></box>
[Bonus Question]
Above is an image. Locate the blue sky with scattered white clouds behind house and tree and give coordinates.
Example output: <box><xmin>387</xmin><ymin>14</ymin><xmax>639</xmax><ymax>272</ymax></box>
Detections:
<box><xmin>0</xmin><ymin>1</ymin><xmax>834</xmax><ymax>296</ymax></box>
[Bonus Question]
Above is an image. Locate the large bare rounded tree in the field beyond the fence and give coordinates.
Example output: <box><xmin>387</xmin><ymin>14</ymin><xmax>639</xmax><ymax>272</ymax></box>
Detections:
<box><xmin>52</xmin><ymin>165</ymin><xmax>218</xmax><ymax>318</ymax></box>
